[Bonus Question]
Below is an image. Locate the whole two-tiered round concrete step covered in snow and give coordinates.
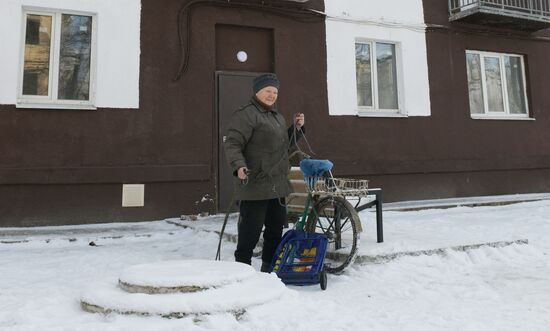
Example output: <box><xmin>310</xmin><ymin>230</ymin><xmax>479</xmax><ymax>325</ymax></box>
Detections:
<box><xmin>80</xmin><ymin>260</ymin><xmax>289</xmax><ymax>318</ymax></box>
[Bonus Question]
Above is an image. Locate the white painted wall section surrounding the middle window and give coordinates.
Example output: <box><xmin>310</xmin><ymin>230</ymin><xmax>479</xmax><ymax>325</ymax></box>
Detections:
<box><xmin>325</xmin><ymin>0</ymin><xmax>430</xmax><ymax>116</ymax></box>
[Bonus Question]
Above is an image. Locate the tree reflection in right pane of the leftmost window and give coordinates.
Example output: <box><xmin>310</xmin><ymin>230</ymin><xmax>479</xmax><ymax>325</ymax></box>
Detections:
<box><xmin>58</xmin><ymin>14</ymin><xmax>92</xmax><ymax>100</ymax></box>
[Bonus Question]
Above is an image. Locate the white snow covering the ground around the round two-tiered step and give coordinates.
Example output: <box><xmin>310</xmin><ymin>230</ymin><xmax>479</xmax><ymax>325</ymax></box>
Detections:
<box><xmin>0</xmin><ymin>200</ymin><xmax>550</xmax><ymax>330</ymax></box>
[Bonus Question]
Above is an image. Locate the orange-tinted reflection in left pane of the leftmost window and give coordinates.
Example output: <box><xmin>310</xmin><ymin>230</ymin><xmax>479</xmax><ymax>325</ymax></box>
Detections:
<box><xmin>23</xmin><ymin>15</ymin><xmax>52</xmax><ymax>96</ymax></box>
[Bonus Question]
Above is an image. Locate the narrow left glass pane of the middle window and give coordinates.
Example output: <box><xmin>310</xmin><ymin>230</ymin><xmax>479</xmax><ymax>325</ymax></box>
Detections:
<box><xmin>355</xmin><ymin>43</ymin><xmax>372</xmax><ymax>107</ymax></box>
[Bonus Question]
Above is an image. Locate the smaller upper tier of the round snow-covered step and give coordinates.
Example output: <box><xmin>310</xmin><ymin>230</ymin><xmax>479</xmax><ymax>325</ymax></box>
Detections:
<box><xmin>119</xmin><ymin>260</ymin><xmax>257</xmax><ymax>294</ymax></box>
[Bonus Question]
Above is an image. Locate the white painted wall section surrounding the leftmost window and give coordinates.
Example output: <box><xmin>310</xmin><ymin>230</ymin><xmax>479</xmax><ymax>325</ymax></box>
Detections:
<box><xmin>0</xmin><ymin>0</ymin><xmax>141</xmax><ymax>108</ymax></box>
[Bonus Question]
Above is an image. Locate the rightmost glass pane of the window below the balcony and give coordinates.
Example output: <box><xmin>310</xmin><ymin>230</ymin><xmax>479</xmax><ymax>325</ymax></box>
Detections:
<box><xmin>504</xmin><ymin>56</ymin><xmax>527</xmax><ymax>114</ymax></box>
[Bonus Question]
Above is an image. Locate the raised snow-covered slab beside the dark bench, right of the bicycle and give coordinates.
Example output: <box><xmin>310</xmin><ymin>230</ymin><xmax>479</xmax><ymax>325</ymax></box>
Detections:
<box><xmin>359</xmin><ymin>201</ymin><xmax>548</xmax><ymax>257</ymax></box>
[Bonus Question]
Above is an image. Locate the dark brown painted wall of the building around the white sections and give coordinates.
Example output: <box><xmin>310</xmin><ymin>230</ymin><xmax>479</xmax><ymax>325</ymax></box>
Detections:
<box><xmin>4</xmin><ymin>0</ymin><xmax>550</xmax><ymax>226</ymax></box>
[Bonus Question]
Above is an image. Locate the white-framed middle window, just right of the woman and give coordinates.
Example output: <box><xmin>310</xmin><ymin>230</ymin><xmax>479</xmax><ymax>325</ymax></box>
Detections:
<box><xmin>355</xmin><ymin>41</ymin><xmax>399</xmax><ymax>113</ymax></box>
